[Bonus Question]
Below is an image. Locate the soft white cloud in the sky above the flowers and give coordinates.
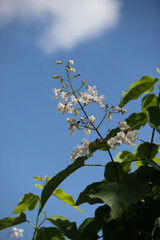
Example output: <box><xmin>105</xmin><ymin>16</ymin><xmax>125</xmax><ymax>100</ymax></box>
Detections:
<box><xmin>0</xmin><ymin>0</ymin><xmax>121</xmax><ymax>53</ymax></box>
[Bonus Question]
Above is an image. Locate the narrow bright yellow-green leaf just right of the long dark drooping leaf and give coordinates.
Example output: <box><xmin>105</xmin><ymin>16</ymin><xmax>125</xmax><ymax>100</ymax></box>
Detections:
<box><xmin>53</xmin><ymin>188</ymin><xmax>84</xmax><ymax>213</ymax></box>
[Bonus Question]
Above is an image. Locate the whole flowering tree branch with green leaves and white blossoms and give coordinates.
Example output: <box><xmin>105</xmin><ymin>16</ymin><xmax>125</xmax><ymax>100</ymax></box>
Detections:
<box><xmin>0</xmin><ymin>60</ymin><xmax>160</xmax><ymax>240</ymax></box>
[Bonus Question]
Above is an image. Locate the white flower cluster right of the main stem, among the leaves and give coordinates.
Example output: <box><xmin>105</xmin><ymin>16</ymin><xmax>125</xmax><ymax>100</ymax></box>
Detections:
<box><xmin>107</xmin><ymin>121</ymin><xmax>138</xmax><ymax>149</ymax></box>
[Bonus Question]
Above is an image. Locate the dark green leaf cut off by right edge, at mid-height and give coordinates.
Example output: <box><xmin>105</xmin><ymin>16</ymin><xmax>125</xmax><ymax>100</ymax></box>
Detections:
<box><xmin>146</xmin><ymin>107</ymin><xmax>160</xmax><ymax>133</ymax></box>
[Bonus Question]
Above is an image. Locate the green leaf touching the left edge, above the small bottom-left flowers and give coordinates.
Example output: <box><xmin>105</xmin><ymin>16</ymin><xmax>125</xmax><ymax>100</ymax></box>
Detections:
<box><xmin>0</xmin><ymin>213</ymin><xmax>26</xmax><ymax>230</ymax></box>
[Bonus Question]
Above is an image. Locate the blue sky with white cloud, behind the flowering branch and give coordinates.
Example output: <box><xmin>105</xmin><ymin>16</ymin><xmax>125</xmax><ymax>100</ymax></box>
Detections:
<box><xmin>0</xmin><ymin>0</ymin><xmax>160</xmax><ymax>240</ymax></box>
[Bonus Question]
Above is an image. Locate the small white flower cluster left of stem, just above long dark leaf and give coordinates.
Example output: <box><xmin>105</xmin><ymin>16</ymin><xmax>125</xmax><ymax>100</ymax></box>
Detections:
<box><xmin>69</xmin><ymin>138</ymin><xmax>92</xmax><ymax>162</ymax></box>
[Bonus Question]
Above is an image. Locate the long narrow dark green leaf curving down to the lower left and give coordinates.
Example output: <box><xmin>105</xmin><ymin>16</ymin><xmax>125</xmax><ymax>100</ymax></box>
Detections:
<box><xmin>39</xmin><ymin>156</ymin><xmax>88</xmax><ymax>213</ymax></box>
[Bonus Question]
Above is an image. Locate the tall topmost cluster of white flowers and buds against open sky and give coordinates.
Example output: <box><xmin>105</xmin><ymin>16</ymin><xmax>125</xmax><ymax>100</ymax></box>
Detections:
<box><xmin>52</xmin><ymin>60</ymin><xmax>105</xmax><ymax>136</ymax></box>
